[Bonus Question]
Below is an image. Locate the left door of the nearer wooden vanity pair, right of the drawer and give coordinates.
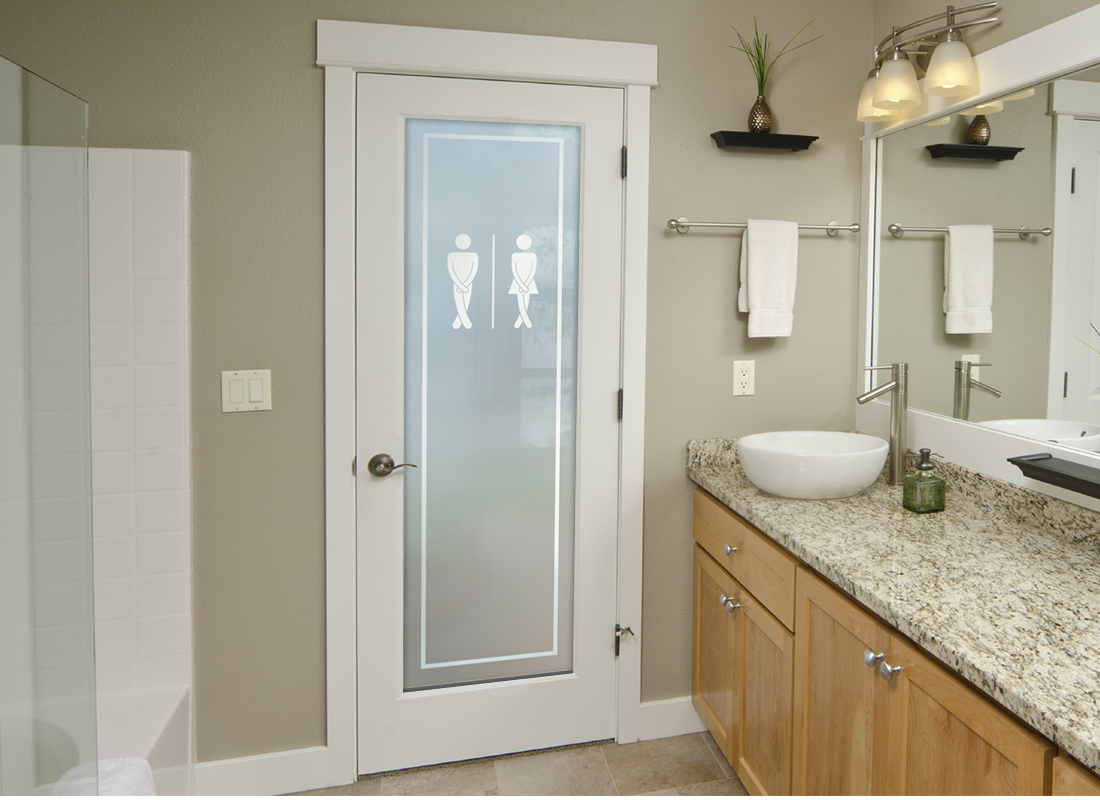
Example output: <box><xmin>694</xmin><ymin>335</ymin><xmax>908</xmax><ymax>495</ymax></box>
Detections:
<box><xmin>792</xmin><ymin>568</ymin><xmax>890</xmax><ymax>794</ymax></box>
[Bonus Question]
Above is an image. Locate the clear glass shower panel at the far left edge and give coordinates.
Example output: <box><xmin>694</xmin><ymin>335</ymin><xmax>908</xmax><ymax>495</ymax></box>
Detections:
<box><xmin>0</xmin><ymin>58</ymin><xmax>97</xmax><ymax>794</ymax></box>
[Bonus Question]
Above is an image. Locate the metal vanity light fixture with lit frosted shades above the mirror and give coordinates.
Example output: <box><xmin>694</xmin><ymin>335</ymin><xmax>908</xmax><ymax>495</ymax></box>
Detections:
<box><xmin>856</xmin><ymin>2</ymin><xmax>1000</xmax><ymax>122</ymax></box>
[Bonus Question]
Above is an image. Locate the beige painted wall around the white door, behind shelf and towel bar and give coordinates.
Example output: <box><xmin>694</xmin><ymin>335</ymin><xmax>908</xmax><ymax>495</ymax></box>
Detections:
<box><xmin>8</xmin><ymin>0</ymin><xmax>1068</xmax><ymax>760</ymax></box>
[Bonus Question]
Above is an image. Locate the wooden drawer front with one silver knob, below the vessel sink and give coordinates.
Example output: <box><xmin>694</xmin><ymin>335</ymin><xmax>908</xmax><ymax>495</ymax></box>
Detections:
<box><xmin>692</xmin><ymin>489</ymin><xmax>799</xmax><ymax>631</ymax></box>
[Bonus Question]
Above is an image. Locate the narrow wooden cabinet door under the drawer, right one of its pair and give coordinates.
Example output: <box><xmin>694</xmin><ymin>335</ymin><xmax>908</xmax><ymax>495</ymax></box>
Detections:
<box><xmin>734</xmin><ymin>591</ymin><xmax>794</xmax><ymax>794</ymax></box>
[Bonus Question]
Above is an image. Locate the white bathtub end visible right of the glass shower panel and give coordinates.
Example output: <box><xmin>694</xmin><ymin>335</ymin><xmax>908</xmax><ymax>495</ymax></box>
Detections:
<box><xmin>96</xmin><ymin>686</ymin><xmax>195</xmax><ymax>794</ymax></box>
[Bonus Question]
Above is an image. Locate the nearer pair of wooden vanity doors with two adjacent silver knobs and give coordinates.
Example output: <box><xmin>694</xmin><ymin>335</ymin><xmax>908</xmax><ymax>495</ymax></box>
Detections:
<box><xmin>794</xmin><ymin>568</ymin><xmax>1055</xmax><ymax>794</ymax></box>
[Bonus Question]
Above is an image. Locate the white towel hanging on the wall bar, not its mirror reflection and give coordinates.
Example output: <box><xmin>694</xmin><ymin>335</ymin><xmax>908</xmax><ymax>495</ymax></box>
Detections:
<box><xmin>737</xmin><ymin>219</ymin><xmax>799</xmax><ymax>337</ymax></box>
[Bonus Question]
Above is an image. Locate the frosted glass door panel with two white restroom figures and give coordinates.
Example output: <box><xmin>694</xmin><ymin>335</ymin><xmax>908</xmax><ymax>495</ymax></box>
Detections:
<box><xmin>404</xmin><ymin>119</ymin><xmax>581</xmax><ymax>691</ymax></box>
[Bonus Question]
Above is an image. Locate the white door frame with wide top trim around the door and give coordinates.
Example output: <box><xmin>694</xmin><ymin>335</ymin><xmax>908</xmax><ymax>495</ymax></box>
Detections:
<box><xmin>317</xmin><ymin>20</ymin><xmax>657</xmax><ymax>786</ymax></box>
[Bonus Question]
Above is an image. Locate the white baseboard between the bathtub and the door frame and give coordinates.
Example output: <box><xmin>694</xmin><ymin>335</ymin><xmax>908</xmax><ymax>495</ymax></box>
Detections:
<box><xmin>195</xmin><ymin>747</ymin><xmax>329</xmax><ymax>796</ymax></box>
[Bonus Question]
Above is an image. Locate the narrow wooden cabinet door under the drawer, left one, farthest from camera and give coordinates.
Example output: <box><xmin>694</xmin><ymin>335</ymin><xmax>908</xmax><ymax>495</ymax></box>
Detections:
<box><xmin>691</xmin><ymin>545</ymin><xmax>743</xmax><ymax>764</ymax></box>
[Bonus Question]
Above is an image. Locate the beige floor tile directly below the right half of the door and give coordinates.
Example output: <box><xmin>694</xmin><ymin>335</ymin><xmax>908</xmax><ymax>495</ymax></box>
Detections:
<box><xmin>494</xmin><ymin>746</ymin><xmax>616</xmax><ymax>796</ymax></box>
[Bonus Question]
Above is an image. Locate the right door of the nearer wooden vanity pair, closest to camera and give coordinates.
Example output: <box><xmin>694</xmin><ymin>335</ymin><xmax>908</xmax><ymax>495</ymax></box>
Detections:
<box><xmin>887</xmin><ymin>636</ymin><xmax>1055</xmax><ymax>794</ymax></box>
